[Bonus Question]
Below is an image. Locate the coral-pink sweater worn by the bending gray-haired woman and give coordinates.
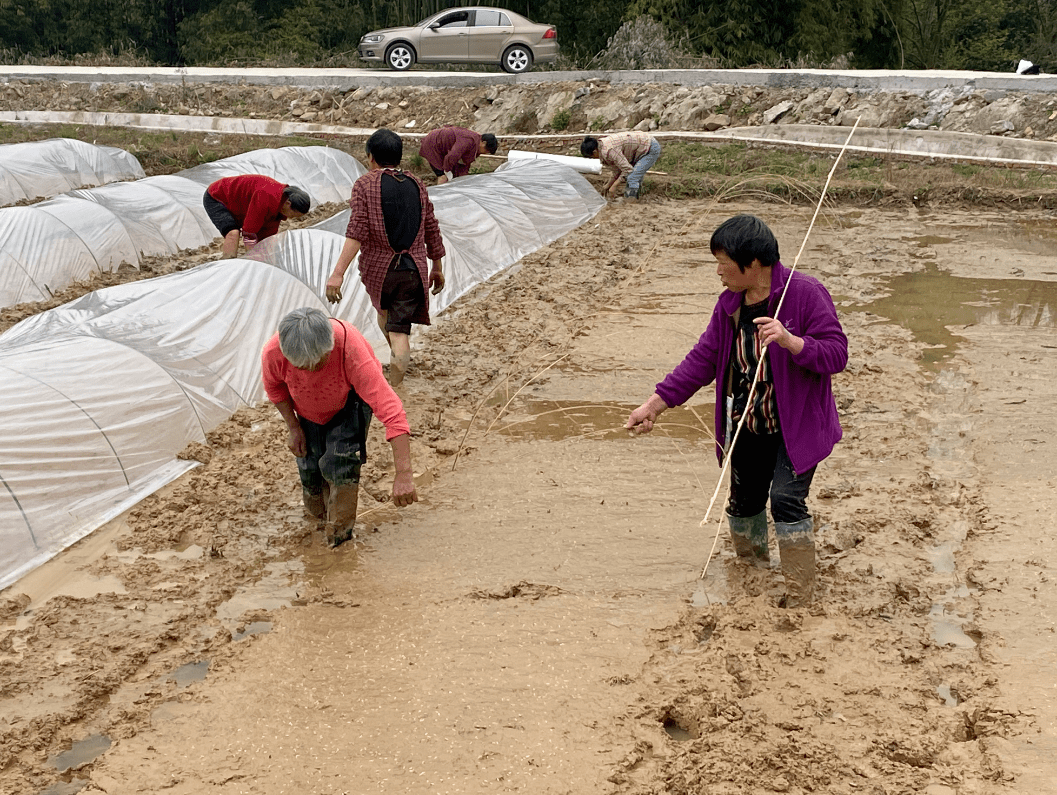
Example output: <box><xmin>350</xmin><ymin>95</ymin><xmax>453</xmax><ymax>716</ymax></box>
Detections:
<box><xmin>261</xmin><ymin>318</ymin><xmax>411</xmax><ymax>441</ymax></box>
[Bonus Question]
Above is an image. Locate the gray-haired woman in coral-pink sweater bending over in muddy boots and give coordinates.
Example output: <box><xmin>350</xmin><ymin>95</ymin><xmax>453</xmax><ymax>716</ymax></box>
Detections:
<box><xmin>262</xmin><ymin>308</ymin><xmax>419</xmax><ymax>547</ymax></box>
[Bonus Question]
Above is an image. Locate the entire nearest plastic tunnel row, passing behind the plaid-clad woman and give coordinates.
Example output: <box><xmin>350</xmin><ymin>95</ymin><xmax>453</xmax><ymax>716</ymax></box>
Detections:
<box><xmin>0</xmin><ymin>158</ymin><xmax>602</xmax><ymax>588</ymax></box>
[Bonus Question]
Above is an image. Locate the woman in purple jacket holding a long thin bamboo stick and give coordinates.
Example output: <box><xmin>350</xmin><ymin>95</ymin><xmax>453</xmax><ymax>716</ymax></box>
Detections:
<box><xmin>627</xmin><ymin>216</ymin><xmax>848</xmax><ymax>607</ymax></box>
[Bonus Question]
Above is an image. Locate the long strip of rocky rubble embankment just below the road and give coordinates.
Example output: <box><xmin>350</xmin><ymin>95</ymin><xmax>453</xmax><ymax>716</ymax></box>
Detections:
<box><xmin>0</xmin><ymin>79</ymin><xmax>1057</xmax><ymax>141</ymax></box>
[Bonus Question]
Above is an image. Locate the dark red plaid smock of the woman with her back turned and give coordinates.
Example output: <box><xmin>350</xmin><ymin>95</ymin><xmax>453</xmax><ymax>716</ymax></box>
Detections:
<box><xmin>345</xmin><ymin>168</ymin><xmax>444</xmax><ymax>326</ymax></box>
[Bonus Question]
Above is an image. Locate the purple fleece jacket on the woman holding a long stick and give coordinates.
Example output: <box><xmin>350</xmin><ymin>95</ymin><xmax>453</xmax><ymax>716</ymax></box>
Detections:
<box><xmin>656</xmin><ymin>262</ymin><xmax>848</xmax><ymax>473</ymax></box>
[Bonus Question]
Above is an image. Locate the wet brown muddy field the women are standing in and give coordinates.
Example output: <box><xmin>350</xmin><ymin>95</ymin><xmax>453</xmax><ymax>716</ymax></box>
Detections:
<box><xmin>0</xmin><ymin>171</ymin><xmax>1057</xmax><ymax>795</ymax></box>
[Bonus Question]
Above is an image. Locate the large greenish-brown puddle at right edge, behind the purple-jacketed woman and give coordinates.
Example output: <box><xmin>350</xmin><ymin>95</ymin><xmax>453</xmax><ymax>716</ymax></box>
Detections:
<box><xmin>860</xmin><ymin>264</ymin><xmax>1057</xmax><ymax>370</ymax></box>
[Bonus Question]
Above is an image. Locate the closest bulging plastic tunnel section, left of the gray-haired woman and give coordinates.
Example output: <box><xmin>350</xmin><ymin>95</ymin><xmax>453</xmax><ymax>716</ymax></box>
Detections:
<box><xmin>0</xmin><ymin>260</ymin><xmax>323</xmax><ymax>587</ymax></box>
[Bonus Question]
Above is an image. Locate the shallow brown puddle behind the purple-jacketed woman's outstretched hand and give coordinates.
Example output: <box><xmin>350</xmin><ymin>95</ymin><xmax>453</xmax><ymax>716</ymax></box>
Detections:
<box><xmin>493</xmin><ymin>398</ymin><xmax>712</xmax><ymax>442</ymax></box>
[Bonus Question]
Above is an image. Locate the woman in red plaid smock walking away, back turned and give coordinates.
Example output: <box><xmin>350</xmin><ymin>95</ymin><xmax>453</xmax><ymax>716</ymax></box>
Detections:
<box><xmin>327</xmin><ymin>129</ymin><xmax>444</xmax><ymax>387</ymax></box>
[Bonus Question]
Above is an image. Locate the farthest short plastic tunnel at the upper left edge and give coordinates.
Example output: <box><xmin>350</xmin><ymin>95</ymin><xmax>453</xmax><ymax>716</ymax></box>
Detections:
<box><xmin>0</xmin><ymin>138</ymin><xmax>144</xmax><ymax>205</ymax></box>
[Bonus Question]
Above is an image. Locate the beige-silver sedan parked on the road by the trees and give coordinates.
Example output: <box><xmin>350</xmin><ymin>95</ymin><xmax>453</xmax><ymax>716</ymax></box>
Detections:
<box><xmin>358</xmin><ymin>6</ymin><xmax>558</xmax><ymax>74</ymax></box>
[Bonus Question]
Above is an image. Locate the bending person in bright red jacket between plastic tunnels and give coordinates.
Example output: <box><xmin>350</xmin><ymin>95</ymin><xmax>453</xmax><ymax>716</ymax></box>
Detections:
<box><xmin>202</xmin><ymin>174</ymin><xmax>312</xmax><ymax>259</ymax></box>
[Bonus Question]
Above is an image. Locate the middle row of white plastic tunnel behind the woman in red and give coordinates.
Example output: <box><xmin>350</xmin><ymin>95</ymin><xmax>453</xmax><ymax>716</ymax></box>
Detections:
<box><xmin>0</xmin><ymin>147</ymin><xmax>366</xmax><ymax>307</ymax></box>
